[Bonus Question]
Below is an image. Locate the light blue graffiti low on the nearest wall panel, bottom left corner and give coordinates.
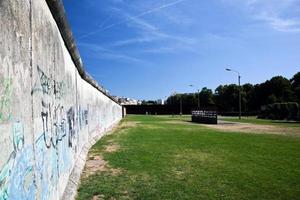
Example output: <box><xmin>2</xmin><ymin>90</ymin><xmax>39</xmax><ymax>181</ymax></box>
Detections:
<box><xmin>0</xmin><ymin>121</ymin><xmax>34</xmax><ymax>200</ymax></box>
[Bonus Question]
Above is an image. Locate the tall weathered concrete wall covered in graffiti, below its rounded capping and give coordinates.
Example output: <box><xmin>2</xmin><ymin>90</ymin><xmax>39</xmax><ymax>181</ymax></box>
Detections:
<box><xmin>0</xmin><ymin>0</ymin><xmax>122</xmax><ymax>200</ymax></box>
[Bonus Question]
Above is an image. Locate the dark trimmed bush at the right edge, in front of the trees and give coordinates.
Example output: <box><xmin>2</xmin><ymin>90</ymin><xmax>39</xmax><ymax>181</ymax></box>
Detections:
<box><xmin>258</xmin><ymin>102</ymin><xmax>300</xmax><ymax>120</ymax></box>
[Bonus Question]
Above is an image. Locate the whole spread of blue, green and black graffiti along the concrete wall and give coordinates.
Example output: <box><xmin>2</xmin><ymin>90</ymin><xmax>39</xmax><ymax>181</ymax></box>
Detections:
<box><xmin>0</xmin><ymin>61</ymin><xmax>121</xmax><ymax>200</ymax></box>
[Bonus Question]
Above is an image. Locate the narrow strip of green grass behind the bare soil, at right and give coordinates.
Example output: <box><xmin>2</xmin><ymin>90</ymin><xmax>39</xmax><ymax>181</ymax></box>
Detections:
<box><xmin>219</xmin><ymin>117</ymin><xmax>300</xmax><ymax>127</ymax></box>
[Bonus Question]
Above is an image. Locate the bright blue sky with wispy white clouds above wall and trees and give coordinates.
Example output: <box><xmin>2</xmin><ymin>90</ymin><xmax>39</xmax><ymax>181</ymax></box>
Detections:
<box><xmin>64</xmin><ymin>0</ymin><xmax>300</xmax><ymax>99</ymax></box>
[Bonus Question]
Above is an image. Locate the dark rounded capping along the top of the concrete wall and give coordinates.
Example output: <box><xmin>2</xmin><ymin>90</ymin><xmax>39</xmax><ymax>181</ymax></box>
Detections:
<box><xmin>46</xmin><ymin>0</ymin><xmax>120</xmax><ymax>105</ymax></box>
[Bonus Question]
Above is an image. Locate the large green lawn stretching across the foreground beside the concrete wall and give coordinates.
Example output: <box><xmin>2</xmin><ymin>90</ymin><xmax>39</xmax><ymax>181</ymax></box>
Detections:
<box><xmin>77</xmin><ymin>116</ymin><xmax>300</xmax><ymax>200</ymax></box>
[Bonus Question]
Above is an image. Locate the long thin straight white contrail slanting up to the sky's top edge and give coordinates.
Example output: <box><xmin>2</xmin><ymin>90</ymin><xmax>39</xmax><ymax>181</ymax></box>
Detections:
<box><xmin>79</xmin><ymin>0</ymin><xmax>186</xmax><ymax>39</ymax></box>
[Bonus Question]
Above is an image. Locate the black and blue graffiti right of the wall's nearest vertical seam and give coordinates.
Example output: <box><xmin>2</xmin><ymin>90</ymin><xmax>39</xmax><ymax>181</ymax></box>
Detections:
<box><xmin>32</xmin><ymin>66</ymin><xmax>88</xmax><ymax>199</ymax></box>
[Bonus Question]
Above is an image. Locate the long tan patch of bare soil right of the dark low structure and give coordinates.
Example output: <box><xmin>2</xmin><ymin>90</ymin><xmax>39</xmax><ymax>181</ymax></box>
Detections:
<box><xmin>203</xmin><ymin>122</ymin><xmax>300</xmax><ymax>136</ymax></box>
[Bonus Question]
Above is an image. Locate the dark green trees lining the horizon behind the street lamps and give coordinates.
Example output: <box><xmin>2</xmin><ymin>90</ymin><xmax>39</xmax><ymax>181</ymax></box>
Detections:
<box><xmin>166</xmin><ymin>72</ymin><xmax>300</xmax><ymax>113</ymax></box>
